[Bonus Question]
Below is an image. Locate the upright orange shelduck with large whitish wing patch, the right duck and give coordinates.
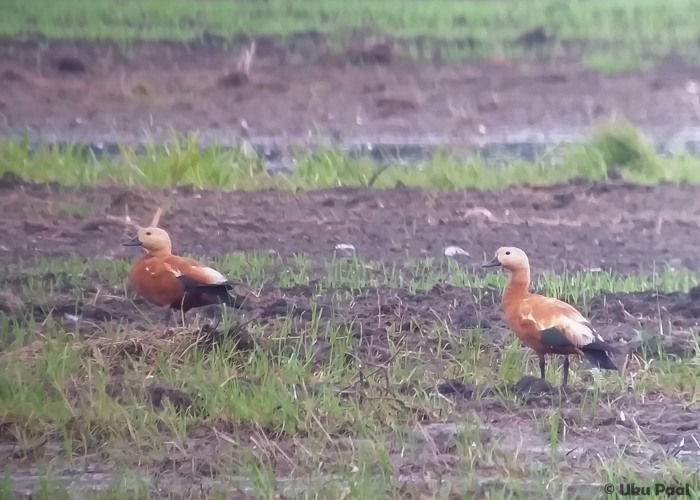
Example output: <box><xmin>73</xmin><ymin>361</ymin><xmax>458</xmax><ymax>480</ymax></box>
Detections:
<box><xmin>482</xmin><ymin>247</ymin><xmax>617</xmax><ymax>386</ymax></box>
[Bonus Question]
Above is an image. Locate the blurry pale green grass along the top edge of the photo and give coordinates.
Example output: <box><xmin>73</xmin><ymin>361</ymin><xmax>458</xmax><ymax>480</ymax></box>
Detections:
<box><xmin>0</xmin><ymin>0</ymin><xmax>700</xmax><ymax>70</ymax></box>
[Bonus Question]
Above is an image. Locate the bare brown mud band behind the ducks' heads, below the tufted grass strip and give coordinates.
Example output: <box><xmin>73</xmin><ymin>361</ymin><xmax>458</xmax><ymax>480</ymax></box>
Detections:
<box><xmin>0</xmin><ymin>174</ymin><xmax>700</xmax><ymax>273</ymax></box>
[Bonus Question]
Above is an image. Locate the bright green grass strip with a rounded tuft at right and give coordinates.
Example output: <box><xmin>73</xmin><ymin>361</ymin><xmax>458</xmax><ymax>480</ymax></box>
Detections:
<box><xmin>0</xmin><ymin>123</ymin><xmax>700</xmax><ymax>190</ymax></box>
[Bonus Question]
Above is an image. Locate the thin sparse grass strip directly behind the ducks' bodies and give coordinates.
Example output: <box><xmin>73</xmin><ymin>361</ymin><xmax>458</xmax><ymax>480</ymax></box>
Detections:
<box><xmin>5</xmin><ymin>252</ymin><xmax>700</xmax><ymax>307</ymax></box>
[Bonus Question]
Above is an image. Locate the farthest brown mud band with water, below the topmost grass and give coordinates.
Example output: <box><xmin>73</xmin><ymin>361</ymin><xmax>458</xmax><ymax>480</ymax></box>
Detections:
<box><xmin>0</xmin><ymin>33</ymin><xmax>700</xmax><ymax>142</ymax></box>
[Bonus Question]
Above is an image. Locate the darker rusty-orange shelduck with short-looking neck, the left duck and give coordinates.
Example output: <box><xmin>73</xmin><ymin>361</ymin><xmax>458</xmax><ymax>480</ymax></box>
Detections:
<box><xmin>122</xmin><ymin>209</ymin><xmax>249</xmax><ymax>328</ymax></box>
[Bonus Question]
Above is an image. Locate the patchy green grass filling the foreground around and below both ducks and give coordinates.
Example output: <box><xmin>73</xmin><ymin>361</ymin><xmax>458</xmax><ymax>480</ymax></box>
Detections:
<box><xmin>0</xmin><ymin>253</ymin><xmax>700</xmax><ymax>500</ymax></box>
